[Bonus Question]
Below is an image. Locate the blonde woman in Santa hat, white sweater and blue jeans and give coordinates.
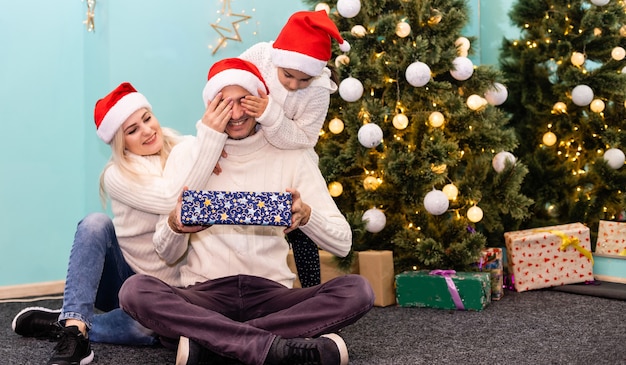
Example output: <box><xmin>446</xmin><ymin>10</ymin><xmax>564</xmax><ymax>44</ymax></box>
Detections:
<box><xmin>12</xmin><ymin>83</ymin><xmax>232</xmax><ymax>365</ymax></box>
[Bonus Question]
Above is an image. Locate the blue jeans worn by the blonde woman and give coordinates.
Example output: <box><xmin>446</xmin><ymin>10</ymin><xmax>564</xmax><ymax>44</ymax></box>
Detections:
<box><xmin>59</xmin><ymin>213</ymin><xmax>158</xmax><ymax>345</ymax></box>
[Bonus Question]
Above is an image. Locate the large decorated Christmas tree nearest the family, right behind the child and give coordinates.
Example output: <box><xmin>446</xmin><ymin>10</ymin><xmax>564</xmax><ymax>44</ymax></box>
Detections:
<box><xmin>302</xmin><ymin>0</ymin><xmax>532</xmax><ymax>272</ymax></box>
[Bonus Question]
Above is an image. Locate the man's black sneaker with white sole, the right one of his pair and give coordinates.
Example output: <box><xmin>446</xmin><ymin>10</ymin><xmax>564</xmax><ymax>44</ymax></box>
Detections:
<box><xmin>265</xmin><ymin>333</ymin><xmax>348</xmax><ymax>365</ymax></box>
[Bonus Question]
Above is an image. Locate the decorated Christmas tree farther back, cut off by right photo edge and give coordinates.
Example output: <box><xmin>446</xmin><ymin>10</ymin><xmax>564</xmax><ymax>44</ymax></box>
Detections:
<box><xmin>501</xmin><ymin>0</ymin><xmax>626</xmax><ymax>242</ymax></box>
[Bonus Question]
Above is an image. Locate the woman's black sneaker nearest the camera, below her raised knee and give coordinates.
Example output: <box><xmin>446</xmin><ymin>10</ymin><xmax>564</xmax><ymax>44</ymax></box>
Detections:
<box><xmin>47</xmin><ymin>326</ymin><xmax>93</xmax><ymax>365</ymax></box>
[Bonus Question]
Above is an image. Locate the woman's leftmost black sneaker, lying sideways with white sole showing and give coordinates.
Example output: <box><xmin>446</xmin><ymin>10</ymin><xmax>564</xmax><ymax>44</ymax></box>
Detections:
<box><xmin>11</xmin><ymin>307</ymin><xmax>61</xmax><ymax>340</ymax></box>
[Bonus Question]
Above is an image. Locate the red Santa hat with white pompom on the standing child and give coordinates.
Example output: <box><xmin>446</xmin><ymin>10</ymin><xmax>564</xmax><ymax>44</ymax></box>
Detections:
<box><xmin>271</xmin><ymin>10</ymin><xmax>350</xmax><ymax>76</ymax></box>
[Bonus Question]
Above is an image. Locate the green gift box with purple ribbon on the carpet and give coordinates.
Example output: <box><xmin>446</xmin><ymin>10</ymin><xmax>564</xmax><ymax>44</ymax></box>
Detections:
<box><xmin>396</xmin><ymin>270</ymin><xmax>491</xmax><ymax>311</ymax></box>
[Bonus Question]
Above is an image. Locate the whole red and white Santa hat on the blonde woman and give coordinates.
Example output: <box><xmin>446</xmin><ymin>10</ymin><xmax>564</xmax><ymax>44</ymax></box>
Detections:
<box><xmin>93</xmin><ymin>82</ymin><xmax>152</xmax><ymax>144</ymax></box>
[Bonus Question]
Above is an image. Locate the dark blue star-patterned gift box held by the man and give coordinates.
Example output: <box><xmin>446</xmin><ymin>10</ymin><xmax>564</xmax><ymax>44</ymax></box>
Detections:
<box><xmin>181</xmin><ymin>190</ymin><xmax>292</xmax><ymax>226</ymax></box>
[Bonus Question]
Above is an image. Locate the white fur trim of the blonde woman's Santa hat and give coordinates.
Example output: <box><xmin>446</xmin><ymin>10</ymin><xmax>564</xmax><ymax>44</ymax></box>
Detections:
<box><xmin>96</xmin><ymin>92</ymin><xmax>152</xmax><ymax>143</ymax></box>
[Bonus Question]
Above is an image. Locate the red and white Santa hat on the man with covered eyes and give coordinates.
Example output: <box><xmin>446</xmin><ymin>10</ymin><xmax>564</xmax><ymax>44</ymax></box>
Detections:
<box><xmin>202</xmin><ymin>58</ymin><xmax>270</xmax><ymax>106</ymax></box>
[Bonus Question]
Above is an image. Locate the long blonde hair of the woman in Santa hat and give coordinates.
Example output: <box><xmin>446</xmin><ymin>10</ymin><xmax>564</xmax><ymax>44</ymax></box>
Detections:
<box><xmin>100</xmin><ymin>123</ymin><xmax>182</xmax><ymax>209</ymax></box>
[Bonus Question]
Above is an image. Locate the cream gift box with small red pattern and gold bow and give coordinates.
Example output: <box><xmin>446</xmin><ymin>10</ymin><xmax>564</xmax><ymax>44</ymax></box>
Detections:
<box><xmin>504</xmin><ymin>223</ymin><xmax>593</xmax><ymax>292</ymax></box>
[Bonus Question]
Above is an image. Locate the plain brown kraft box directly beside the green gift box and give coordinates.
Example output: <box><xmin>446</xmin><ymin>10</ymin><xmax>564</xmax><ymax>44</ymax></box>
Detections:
<box><xmin>359</xmin><ymin>250</ymin><xmax>396</xmax><ymax>307</ymax></box>
